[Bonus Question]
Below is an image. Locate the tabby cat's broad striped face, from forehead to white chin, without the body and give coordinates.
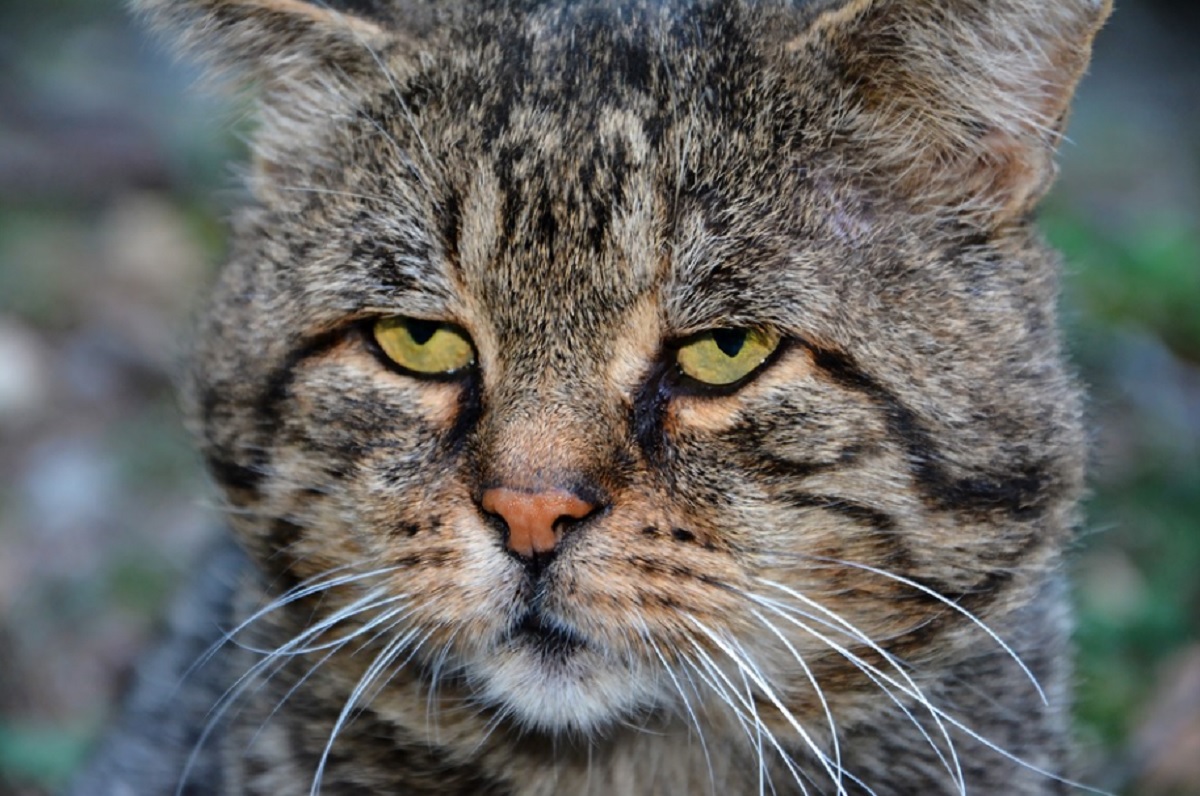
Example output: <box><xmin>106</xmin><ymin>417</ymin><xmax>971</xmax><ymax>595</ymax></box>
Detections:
<box><xmin>167</xmin><ymin>1</ymin><xmax>1102</xmax><ymax>731</ymax></box>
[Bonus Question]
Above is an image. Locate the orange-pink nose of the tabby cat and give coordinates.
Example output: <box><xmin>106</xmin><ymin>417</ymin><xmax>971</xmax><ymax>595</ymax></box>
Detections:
<box><xmin>479</xmin><ymin>487</ymin><xmax>599</xmax><ymax>559</ymax></box>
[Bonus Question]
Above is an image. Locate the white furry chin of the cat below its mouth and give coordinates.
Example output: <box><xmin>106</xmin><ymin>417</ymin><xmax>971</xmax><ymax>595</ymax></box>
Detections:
<box><xmin>473</xmin><ymin>628</ymin><xmax>660</xmax><ymax>736</ymax></box>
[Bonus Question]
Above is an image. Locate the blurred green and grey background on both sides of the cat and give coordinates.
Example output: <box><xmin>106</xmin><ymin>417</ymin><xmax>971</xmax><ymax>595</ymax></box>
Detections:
<box><xmin>0</xmin><ymin>0</ymin><xmax>1200</xmax><ymax>796</ymax></box>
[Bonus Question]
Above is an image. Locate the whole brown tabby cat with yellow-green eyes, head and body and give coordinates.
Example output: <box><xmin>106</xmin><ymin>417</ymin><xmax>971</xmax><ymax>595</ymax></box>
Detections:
<box><xmin>77</xmin><ymin>0</ymin><xmax>1110</xmax><ymax>796</ymax></box>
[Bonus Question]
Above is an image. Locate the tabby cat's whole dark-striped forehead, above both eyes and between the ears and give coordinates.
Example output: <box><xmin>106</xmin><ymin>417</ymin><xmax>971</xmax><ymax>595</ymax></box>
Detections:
<box><xmin>262</xmin><ymin>4</ymin><xmax>858</xmax><ymax>357</ymax></box>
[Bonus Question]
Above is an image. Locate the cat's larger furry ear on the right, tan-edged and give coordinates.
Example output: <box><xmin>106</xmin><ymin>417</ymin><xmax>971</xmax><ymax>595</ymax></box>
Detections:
<box><xmin>792</xmin><ymin>0</ymin><xmax>1111</xmax><ymax>223</ymax></box>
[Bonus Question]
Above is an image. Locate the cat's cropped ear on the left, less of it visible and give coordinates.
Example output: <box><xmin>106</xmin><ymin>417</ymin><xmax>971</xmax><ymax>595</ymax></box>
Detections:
<box><xmin>131</xmin><ymin>0</ymin><xmax>396</xmax><ymax>92</ymax></box>
